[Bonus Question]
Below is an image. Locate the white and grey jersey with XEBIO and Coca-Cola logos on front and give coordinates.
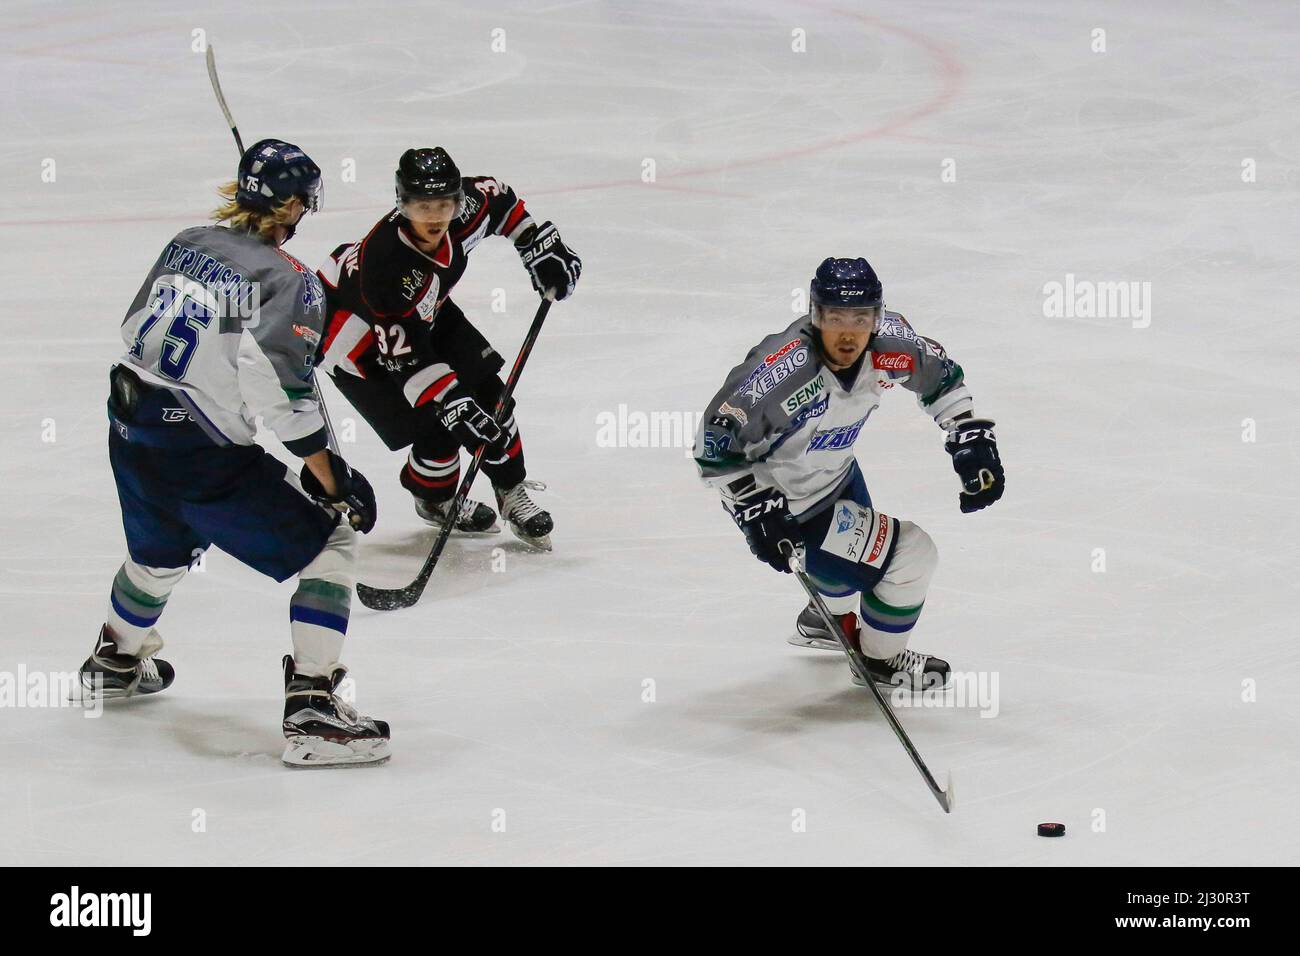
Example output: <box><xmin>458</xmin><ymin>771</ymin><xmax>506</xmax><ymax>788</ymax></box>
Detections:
<box><xmin>694</xmin><ymin>311</ymin><xmax>972</xmax><ymax>515</ymax></box>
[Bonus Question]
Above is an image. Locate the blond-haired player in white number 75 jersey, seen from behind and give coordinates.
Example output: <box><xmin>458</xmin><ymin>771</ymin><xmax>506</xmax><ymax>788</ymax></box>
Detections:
<box><xmin>81</xmin><ymin>139</ymin><xmax>389</xmax><ymax>766</ymax></box>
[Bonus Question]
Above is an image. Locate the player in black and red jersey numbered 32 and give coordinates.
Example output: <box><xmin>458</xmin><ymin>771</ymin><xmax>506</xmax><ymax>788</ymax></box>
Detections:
<box><xmin>319</xmin><ymin>147</ymin><xmax>582</xmax><ymax>550</ymax></box>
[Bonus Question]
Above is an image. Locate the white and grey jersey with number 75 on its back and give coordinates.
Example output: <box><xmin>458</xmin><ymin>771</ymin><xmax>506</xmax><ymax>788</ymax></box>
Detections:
<box><xmin>122</xmin><ymin>225</ymin><xmax>326</xmax><ymax>457</ymax></box>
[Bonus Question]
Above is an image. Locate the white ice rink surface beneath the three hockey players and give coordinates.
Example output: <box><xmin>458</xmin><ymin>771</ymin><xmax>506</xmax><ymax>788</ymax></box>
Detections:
<box><xmin>0</xmin><ymin>0</ymin><xmax>1300</xmax><ymax>865</ymax></box>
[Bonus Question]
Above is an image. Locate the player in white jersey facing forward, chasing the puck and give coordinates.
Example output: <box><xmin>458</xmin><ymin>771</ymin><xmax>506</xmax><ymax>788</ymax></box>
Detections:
<box><xmin>696</xmin><ymin>259</ymin><xmax>1004</xmax><ymax>689</ymax></box>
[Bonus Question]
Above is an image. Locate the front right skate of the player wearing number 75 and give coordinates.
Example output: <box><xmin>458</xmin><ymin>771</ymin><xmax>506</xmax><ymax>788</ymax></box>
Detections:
<box><xmin>281</xmin><ymin>654</ymin><xmax>390</xmax><ymax>767</ymax></box>
